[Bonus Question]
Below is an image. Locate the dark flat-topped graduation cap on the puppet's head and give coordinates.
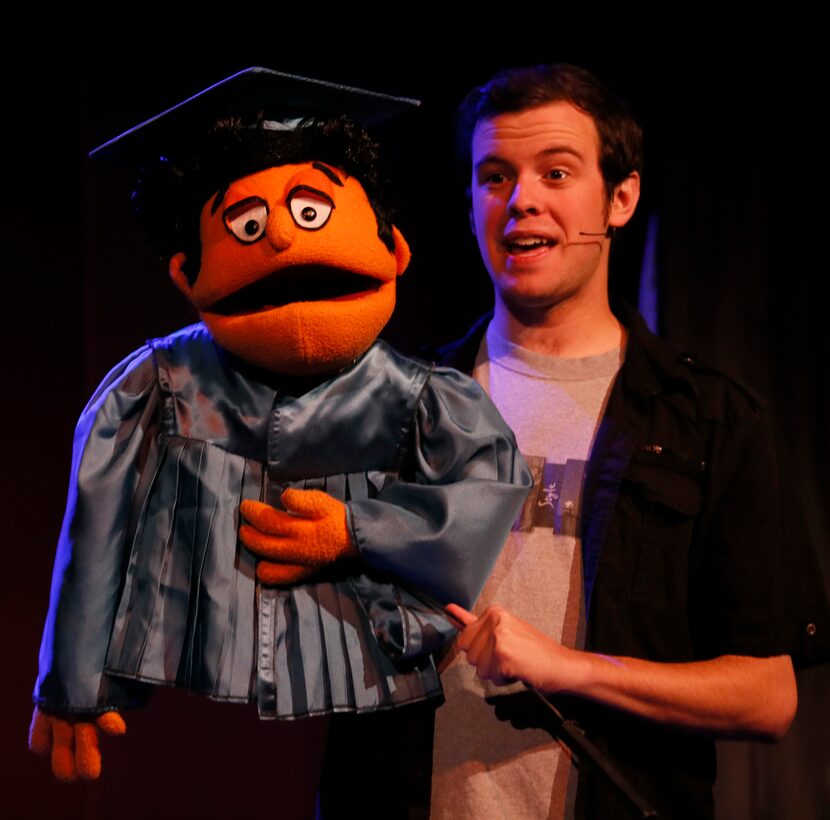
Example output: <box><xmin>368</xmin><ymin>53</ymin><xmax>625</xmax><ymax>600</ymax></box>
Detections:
<box><xmin>89</xmin><ymin>66</ymin><xmax>421</xmax><ymax>165</ymax></box>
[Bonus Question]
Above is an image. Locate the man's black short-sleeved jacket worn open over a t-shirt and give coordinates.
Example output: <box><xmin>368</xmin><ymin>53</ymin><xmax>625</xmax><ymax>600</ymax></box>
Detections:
<box><xmin>442</xmin><ymin>309</ymin><xmax>830</xmax><ymax>820</ymax></box>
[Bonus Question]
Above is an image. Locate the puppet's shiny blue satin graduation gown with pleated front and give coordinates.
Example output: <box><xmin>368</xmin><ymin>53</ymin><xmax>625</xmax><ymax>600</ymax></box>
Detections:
<box><xmin>35</xmin><ymin>325</ymin><xmax>530</xmax><ymax>718</ymax></box>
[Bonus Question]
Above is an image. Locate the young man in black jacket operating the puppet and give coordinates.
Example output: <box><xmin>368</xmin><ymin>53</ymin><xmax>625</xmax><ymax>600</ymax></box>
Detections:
<box><xmin>432</xmin><ymin>65</ymin><xmax>828</xmax><ymax>818</ymax></box>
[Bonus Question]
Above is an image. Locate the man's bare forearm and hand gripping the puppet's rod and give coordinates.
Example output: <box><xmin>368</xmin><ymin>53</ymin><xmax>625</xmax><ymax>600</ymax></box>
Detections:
<box><xmin>446</xmin><ymin>604</ymin><xmax>798</xmax><ymax>741</ymax></box>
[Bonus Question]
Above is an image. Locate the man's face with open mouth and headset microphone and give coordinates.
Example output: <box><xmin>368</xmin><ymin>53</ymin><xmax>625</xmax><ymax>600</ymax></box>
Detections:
<box><xmin>471</xmin><ymin>102</ymin><xmax>639</xmax><ymax>311</ymax></box>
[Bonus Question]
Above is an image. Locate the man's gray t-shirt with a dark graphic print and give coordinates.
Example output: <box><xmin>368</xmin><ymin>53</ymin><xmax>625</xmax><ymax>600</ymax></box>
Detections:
<box><xmin>431</xmin><ymin>325</ymin><xmax>622</xmax><ymax>820</ymax></box>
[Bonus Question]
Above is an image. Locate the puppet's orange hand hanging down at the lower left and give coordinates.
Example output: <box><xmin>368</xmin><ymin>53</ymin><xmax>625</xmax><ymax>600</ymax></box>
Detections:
<box><xmin>29</xmin><ymin>706</ymin><xmax>127</xmax><ymax>781</ymax></box>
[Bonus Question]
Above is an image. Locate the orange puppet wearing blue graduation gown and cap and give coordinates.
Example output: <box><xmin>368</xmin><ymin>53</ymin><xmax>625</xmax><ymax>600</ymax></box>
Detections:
<box><xmin>31</xmin><ymin>69</ymin><xmax>529</xmax><ymax>779</ymax></box>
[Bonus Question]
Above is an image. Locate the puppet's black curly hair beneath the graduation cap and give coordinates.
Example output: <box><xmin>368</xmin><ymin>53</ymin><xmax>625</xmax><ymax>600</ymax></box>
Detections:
<box><xmin>132</xmin><ymin>112</ymin><xmax>395</xmax><ymax>284</ymax></box>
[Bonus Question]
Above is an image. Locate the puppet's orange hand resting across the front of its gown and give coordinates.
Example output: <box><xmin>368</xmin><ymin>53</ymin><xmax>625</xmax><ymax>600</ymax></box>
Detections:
<box><xmin>239</xmin><ymin>489</ymin><xmax>358</xmax><ymax>584</ymax></box>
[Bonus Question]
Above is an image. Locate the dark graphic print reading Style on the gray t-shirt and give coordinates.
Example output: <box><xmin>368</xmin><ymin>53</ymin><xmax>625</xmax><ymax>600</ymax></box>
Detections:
<box><xmin>513</xmin><ymin>453</ymin><xmax>586</xmax><ymax>536</ymax></box>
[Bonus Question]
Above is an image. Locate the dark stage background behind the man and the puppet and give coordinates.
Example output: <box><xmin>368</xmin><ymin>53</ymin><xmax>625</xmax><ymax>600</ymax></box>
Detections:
<box><xmin>0</xmin><ymin>8</ymin><xmax>830</xmax><ymax>820</ymax></box>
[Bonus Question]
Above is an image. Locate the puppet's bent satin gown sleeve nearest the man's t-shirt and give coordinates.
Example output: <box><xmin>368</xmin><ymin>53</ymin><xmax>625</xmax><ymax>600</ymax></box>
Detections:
<box><xmin>348</xmin><ymin>368</ymin><xmax>532</xmax><ymax>608</ymax></box>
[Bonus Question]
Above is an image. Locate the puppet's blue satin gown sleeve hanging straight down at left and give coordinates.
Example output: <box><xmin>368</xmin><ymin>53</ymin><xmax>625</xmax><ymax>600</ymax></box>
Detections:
<box><xmin>34</xmin><ymin>347</ymin><xmax>160</xmax><ymax>713</ymax></box>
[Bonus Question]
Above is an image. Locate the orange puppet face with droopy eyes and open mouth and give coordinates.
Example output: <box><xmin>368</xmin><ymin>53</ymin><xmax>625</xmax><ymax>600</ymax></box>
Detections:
<box><xmin>170</xmin><ymin>162</ymin><xmax>409</xmax><ymax>374</ymax></box>
